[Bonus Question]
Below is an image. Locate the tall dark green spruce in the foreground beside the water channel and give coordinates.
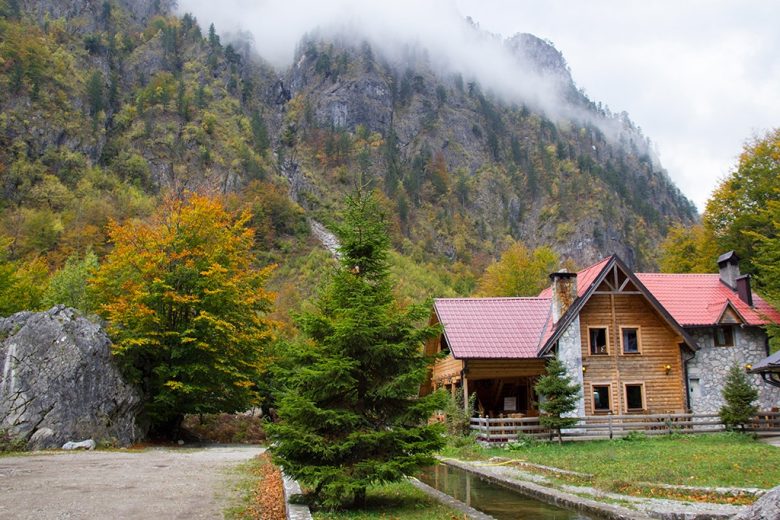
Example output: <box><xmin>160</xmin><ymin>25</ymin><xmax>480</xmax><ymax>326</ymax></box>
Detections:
<box><xmin>269</xmin><ymin>193</ymin><xmax>444</xmax><ymax>507</ymax></box>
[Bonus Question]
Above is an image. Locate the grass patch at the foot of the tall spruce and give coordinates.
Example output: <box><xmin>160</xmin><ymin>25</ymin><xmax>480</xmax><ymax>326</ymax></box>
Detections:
<box><xmin>313</xmin><ymin>482</ymin><xmax>463</xmax><ymax>520</ymax></box>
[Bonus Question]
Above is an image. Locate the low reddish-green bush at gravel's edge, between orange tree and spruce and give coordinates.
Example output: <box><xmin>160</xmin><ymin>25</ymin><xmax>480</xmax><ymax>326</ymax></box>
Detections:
<box><xmin>182</xmin><ymin>413</ymin><xmax>265</xmax><ymax>444</ymax></box>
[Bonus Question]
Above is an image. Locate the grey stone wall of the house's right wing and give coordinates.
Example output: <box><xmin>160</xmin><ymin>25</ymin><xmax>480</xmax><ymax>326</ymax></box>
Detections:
<box><xmin>688</xmin><ymin>326</ymin><xmax>780</xmax><ymax>414</ymax></box>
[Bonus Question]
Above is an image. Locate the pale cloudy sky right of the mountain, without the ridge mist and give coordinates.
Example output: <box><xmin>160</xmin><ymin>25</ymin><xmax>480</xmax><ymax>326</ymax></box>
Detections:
<box><xmin>455</xmin><ymin>0</ymin><xmax>780</xmax><ymax>211</ymax></box>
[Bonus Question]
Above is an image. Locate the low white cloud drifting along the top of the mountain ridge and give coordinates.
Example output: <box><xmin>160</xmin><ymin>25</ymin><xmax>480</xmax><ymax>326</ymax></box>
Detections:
<box><xmin>179</xmin><ymin>0</ymin><xmax>614</xmax><ymax>125</ymax></box>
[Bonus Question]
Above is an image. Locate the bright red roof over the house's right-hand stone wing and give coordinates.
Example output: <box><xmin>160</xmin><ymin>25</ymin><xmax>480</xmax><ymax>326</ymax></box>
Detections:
<box><xmin>637</xmin><ymin>273</ymin><xmax>780</xmax><ymax>327</ymax></box>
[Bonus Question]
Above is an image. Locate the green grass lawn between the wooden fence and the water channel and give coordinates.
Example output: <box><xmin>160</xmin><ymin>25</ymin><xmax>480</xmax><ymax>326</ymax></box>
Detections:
<box><xmin>443</xmin><ymin>433</ymin><xmax>780</xmax><ymax>489</ymax></box>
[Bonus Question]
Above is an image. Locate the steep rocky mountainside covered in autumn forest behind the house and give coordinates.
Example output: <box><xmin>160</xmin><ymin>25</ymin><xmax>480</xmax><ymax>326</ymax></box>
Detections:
<box><xmin>0</xmin><ymin>0</ymin><xmax>695</xmax><ymax>312</ymax></box>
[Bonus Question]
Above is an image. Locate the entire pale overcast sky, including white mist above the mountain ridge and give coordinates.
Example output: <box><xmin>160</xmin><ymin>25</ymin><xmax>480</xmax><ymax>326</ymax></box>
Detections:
<box><xmin>179</xmin><ymin>0</ymin><xmax>780</xmax><ymax>211</ymax></box>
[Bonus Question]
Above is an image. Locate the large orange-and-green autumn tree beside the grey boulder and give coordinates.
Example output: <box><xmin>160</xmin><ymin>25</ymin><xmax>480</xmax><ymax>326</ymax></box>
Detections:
<box><xmin>94</xmin><ymin>195</ymin><xmax>271</xmax><ymax>436</ymax></box>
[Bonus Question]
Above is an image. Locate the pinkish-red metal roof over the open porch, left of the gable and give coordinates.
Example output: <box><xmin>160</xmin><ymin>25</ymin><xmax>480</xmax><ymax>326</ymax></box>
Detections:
<box><xmin>433</xmin><ymin>298</ymin><xmax>551</xmax><ymax>359</ymax></box>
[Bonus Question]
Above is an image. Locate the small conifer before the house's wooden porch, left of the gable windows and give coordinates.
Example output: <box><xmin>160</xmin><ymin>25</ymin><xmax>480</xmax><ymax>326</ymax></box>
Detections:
<box><xmin>534</xmin><ymin>358</ymin><xmax>580</xmax><ymax>443</ymax></box>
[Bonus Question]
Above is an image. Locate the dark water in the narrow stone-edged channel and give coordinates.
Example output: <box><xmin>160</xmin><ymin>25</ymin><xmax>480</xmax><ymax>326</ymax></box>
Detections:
<box><xmin>419</xmin><ymin>464</ymin><xmax>590</xmax><ymax>520</ymax></box>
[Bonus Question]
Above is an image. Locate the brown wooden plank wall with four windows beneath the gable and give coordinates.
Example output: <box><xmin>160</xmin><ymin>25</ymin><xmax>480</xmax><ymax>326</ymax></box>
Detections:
<box><xmin>580</xmin><ymin>293</ymin><xmax>687</xmax><ymax>414</ymax></box>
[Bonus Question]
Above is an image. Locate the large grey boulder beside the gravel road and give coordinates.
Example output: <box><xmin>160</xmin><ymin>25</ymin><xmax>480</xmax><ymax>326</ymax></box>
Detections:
<box><xmin>0</xmin><ymin>306</ymin><xmax>142</xmax><ymax>449</ymax></box>
